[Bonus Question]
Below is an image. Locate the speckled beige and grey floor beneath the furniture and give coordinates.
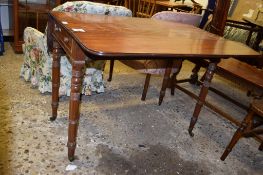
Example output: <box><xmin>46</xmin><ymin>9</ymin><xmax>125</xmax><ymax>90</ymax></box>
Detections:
<box><xmin>0</xmin><ymin>44</ymin><xmax>263</xmax><ymax>175</ymax></box>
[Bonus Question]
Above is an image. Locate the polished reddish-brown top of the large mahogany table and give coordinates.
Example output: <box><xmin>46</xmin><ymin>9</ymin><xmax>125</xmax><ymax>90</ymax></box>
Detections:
<box><xmin>50</xmin><ymin>12</ymin><xmax>260</xmax><ymax>59</ymax></box>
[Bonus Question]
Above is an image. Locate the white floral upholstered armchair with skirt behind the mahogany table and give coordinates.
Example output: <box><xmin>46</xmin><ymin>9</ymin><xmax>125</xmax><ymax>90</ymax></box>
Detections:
<box><xmin>20</xmin><ymin>1</ymin><xmax>132</xmax><ymax>96</ymax></box>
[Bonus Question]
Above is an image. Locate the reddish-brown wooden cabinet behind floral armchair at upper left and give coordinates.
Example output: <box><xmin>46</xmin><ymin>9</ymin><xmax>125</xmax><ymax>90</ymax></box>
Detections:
<box><xmin>12</xmin><ymin>0</ymin><xmax>61</xmax><ymax>53</ymax></box>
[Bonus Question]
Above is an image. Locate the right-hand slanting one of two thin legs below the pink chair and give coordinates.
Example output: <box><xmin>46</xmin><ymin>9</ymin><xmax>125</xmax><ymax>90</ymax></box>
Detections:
<box><xmin>158</xmin><ymin>61</ymin><xmax>172</xmax><ymax>106</ymax></box>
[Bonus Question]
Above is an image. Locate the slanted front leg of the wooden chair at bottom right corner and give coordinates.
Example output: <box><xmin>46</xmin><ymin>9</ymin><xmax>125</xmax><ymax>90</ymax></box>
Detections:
<box><xmin>220</xmin><ymin>110</ymin><xmax>254</xmax><ymax>161</ymax></box>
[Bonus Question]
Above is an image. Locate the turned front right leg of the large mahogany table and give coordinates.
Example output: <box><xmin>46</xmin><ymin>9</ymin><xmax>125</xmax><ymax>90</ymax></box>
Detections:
<box><xmin>188</xmin><ymin>62</ymin><xmax>217</xmax><ymax>137</ymax></box>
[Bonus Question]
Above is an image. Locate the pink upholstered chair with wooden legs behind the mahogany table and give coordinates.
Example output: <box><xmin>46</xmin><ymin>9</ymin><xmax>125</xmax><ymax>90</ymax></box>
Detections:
<box><xmin>108</xmin><ymin>11</ymin><xmax>202</xmax><ymax>105</ymax></box>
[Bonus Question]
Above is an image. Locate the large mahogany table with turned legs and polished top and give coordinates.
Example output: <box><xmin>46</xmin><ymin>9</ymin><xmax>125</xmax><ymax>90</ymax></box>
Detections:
<box><xmin>48</xmin><ymin>12</ymin><xmax>261</xmax><ymax>161</ymax></box>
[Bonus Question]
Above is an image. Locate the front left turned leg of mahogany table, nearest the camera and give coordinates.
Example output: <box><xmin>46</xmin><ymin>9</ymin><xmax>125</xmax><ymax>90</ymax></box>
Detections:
<box><xmin>67</xmin><ymin>61</ymin><xmax>85</xmax><ymax>161</ymax></box>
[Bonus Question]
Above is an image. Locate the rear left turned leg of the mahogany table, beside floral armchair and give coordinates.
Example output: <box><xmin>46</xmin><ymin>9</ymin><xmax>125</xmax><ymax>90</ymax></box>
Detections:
<box><xmin>50</xmin><ymin>41</ymin><xmax>62</xmax><ymax>121</ymax></box>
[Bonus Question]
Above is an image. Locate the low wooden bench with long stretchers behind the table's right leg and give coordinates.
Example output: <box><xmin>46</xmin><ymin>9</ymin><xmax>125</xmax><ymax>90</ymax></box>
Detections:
<box><xmin>183</xmin><ymin>58</ymin><xmax>263</xmax><ymax>132</ymax></box>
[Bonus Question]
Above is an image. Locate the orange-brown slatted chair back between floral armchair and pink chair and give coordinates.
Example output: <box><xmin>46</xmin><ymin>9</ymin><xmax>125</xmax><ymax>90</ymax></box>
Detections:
<box><xmin>136</xmin><ymin>0</ymin><xmax>156</xmax><ymax>18</ymax></box>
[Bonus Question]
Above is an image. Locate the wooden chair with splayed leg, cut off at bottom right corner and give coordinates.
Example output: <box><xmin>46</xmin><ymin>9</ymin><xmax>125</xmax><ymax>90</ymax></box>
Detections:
<box><xmin>220</xmin><ymin>99</ymin><xmax>263</xmax><ymax>161</ymax></box>
